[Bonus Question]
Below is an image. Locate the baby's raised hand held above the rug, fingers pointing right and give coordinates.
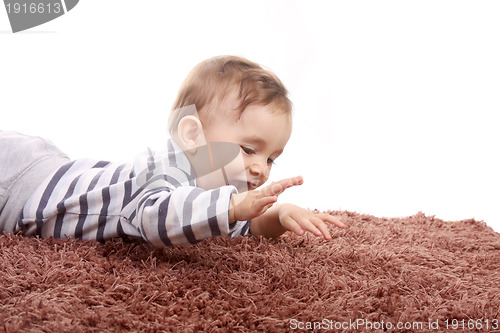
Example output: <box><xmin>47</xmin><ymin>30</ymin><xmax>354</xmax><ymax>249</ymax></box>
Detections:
<box><xmin>229</xmin><ymin>176</ymin><xmax>304</xmax><ymax>222</ymax></box>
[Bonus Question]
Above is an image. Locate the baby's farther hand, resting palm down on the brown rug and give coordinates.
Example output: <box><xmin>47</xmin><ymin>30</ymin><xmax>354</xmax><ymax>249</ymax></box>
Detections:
<box><xmin>279</xmin><ymin>204</ymin><xmax>345</xmax><ymax>240</ymax></box>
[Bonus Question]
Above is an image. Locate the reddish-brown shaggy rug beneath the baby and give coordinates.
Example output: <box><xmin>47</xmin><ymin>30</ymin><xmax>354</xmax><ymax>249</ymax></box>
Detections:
<box><xmin>0</xmin><ymin>212</ymin><xmax>500</xmax><ymax>333</ymax></box>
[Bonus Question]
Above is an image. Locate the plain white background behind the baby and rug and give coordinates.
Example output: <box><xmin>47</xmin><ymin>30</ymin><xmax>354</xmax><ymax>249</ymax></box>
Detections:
<box><xmin>0</xmin><ymin>0</ymin><xmax>500</xmax><ymax>231</ymax></box>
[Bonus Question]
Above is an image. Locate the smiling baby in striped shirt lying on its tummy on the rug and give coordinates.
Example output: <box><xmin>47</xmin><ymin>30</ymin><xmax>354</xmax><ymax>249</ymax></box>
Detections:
<box><xmin>0</xmin><ymin>56</ymin><xmax>344</xmax><ymax>246</ymax></box>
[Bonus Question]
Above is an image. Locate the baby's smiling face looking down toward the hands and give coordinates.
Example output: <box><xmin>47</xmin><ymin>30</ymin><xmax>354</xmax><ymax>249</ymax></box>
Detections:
<box><xmin>198</xmin><ymin>105</ymin><xmax>292</xmax><ymax>192</ymax></box>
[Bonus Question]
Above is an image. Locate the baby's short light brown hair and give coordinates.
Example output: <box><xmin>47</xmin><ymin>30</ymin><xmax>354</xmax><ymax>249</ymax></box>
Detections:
<box><xmin>168</xmin><ymin>56</ymin><xmax>292</xmax><ymax>134</ymax></box>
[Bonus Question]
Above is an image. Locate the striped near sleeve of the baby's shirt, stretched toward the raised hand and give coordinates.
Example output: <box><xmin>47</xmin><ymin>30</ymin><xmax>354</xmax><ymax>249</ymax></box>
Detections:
<box><xmin>130</xmin><ymin>147</ymin><xmax>254</xmax><ymax>246</ymax></box>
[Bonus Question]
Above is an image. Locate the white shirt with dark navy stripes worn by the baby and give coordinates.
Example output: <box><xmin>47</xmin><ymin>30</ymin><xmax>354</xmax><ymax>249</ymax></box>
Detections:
<box><xmin>18</xmin><ymin>140</ymin><xmax>250</xmax><ymax>246</ymax></box>
